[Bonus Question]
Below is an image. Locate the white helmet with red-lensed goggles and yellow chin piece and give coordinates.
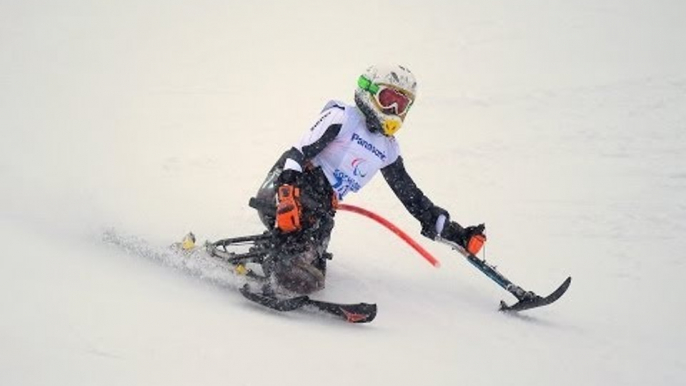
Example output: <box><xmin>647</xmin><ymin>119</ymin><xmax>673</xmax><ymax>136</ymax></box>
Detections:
<box><xmin>355</xmin><ymin>65</ymin><xmax>417</xmax><ymax>137</ymax></box>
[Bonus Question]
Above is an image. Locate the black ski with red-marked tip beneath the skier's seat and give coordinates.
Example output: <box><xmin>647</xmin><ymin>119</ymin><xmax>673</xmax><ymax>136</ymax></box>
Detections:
<box><xmin>240</xmin><ymin>284</ymin><xmax>376</xmax><ymax>323</ymax></box>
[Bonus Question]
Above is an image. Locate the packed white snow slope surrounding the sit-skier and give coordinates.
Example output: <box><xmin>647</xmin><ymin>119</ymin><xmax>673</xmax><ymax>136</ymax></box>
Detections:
<box><xmin>0</xmin><ymin>0</ymin><xmax>686</xmax><ymax>386</ymax></box>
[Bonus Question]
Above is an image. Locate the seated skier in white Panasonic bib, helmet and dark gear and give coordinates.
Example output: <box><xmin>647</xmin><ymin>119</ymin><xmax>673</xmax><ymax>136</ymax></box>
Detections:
<box><xmin>257</xmin><ymin>65</ymin><xmax>486</xmax><ymax>294</ymax></box>
